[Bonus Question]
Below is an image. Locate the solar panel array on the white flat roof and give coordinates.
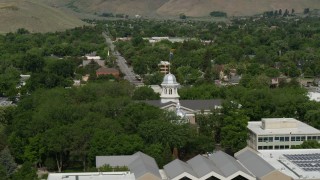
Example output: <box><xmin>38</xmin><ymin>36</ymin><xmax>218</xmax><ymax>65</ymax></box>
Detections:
<box><xmin>283</xmin><ymin>153</ymin><xmax>320</xmax><ymax>172</ymax></box>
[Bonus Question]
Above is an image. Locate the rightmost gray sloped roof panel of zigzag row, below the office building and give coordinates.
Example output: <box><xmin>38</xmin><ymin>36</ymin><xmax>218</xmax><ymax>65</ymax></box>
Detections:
<box><xmin>236</xmin><ymin>149</ymin><xmax>275</xmax><ymax>177</ymax></box>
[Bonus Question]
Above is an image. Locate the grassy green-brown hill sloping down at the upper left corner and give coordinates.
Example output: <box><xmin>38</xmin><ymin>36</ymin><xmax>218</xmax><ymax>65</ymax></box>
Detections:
<box><xmin>0</xmin><ymin>0</ymin><xmax>85</xmax><ymax>33</ymax></box>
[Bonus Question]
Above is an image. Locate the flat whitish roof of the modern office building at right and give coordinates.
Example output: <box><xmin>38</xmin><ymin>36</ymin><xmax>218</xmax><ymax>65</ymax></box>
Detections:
<box><xmin>248</xmin><ymin>118</ymin><xmax>320</xmax><ymax>135</ymax></box>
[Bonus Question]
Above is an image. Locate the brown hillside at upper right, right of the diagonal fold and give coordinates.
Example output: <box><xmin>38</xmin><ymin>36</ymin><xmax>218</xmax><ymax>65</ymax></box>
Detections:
<box><xmin>157</xmin><ymin>0</ymin><xmax>320</xmax><ymax>16</ymax></box>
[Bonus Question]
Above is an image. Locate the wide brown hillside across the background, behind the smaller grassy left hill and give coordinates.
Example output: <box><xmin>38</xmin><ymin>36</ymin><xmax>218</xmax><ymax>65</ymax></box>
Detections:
<box><xmin>45</xmin><ymin>0</ymin><xmax>320</xmax><ymax>17</ymax></box>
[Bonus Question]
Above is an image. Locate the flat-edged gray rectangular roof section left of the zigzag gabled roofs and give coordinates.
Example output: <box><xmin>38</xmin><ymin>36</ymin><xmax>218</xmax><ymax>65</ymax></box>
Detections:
<box><xmin>96</xmin><ymin>155</ymin><xmax>137</xmax><ymax>168</ymax></box>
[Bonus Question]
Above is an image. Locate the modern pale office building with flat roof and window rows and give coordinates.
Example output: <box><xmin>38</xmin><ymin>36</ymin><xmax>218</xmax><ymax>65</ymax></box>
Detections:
<box><xmin>248</xmin><ymin>118</ymin><xmax>320</xmax><ymax>150</ymax></box>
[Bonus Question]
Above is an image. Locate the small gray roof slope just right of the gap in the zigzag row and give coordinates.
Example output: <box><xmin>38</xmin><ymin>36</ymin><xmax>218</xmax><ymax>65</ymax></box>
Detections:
<box><xmin>163</xmin><ymin>159</ymin><xmax>198</xmax><ymax>179</ymax></box>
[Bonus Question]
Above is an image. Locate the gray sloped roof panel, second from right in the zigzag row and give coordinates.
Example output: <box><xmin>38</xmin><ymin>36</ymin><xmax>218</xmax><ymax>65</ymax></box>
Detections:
<box><xmin>209</xmin><ymin>151</ymin><xmax>250</xmax><ymax>177</ymax></box>
